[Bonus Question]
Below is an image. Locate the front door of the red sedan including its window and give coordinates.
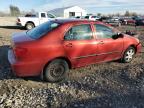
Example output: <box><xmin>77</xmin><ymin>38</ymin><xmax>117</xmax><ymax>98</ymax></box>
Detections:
<box><xmin>94</xmin><ymin>24</ymin><xmax>124</xmax><ymax>62</ymax></box>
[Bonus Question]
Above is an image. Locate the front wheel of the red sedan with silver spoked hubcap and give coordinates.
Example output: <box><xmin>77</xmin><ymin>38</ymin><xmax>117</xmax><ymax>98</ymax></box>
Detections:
<box><xmin>121</xmin><ymin>47</ymin><xmax>135</xmax><ymax>63</ymax></box>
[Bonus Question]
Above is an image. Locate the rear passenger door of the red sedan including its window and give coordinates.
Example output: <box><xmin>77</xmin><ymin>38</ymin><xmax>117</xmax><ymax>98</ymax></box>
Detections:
<box><xmin>64</xmin><ymin>24</ymin><xmax>97</xmax><ymax>67</ymax></box>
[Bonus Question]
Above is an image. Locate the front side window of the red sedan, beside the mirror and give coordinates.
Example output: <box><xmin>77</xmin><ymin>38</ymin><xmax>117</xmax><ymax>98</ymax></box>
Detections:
<box><xmin>94</xmin><ymin>24</ymin><xmax>114</xmax><ymax>39</ymax></box>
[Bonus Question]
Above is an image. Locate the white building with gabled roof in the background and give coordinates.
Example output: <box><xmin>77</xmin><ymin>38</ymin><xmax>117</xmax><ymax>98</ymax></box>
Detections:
<box><xmin>48</xmin><ymin>6</ymin><xmax>87</xmax><ymax>18</ymax></box>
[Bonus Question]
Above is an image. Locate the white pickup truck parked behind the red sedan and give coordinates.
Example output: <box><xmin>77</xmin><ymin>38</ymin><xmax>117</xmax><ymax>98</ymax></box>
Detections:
<box><xmin>16</xmin><ymin>12</ymin><xmax>56</xmax><ymax>30</ymax></box>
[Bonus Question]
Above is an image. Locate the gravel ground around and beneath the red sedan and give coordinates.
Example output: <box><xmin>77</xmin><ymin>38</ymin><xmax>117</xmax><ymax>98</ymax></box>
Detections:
<box><xmin>0</xmin><ymin>26</ymin><xmax>144</xmax><ymax>108</ymax></box>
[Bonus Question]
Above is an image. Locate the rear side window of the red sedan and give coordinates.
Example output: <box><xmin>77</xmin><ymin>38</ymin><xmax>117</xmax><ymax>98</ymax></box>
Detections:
<box><xmin>64</xmin><ymin>24</ymin><xmax>93</xmax><ymax>40</ymax></box>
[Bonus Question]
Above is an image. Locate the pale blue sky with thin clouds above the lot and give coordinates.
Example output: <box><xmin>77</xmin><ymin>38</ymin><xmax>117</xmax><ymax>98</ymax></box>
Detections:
<box><xmin>0</xmin><ymin>0</ymin><xmax>144</xmax><ymax>14</ymax></box>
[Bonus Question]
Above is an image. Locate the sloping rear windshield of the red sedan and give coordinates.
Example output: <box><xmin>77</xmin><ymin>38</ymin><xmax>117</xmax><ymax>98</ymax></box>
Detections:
<box><xmin>27</xmin><ymin>21</ymin><xmax>60</xmax><ymax>39</ymax></box>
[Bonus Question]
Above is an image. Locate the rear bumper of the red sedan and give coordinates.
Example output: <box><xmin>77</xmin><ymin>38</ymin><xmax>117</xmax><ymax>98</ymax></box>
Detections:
<box><xmin>8</xmin><ymin>50</ymin><xmax>42</xmax><ymax>77</ymax></box>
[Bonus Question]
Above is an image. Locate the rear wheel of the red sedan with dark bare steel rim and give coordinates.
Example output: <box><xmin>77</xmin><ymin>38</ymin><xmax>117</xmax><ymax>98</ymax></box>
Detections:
<box><xmin>44</xmin><ymin>59</ymin><xmax>69</xmax><ymax>82</ymax></box>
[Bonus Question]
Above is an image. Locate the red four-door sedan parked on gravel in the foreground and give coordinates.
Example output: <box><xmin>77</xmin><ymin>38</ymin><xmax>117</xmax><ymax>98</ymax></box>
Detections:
<box><xmin>8</xmin><ymin>19</ymin><xmax>141</xmax><ymax>82</ymax></box>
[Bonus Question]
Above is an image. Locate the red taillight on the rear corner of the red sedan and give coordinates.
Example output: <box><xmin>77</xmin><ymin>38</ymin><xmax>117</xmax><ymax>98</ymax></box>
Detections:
<box><xmin>13</xmin><ymin>47</ymin><xmax>28</xmax><ymax>59</ymax></box>
